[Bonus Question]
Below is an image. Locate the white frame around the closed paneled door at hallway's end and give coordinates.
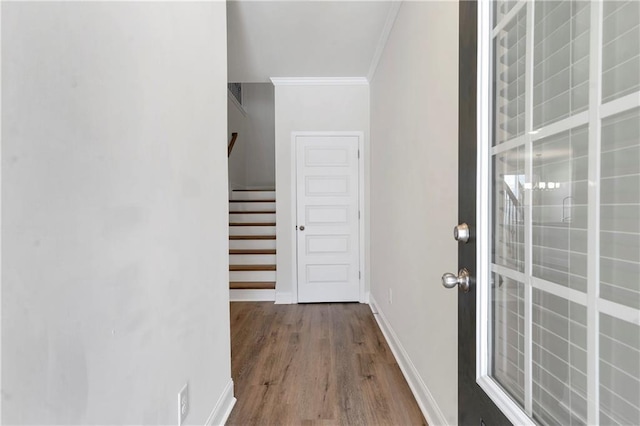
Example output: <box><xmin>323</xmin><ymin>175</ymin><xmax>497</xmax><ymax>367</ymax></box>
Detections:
<box><xmin>290</xmin><ymin>131</ymin><xmax>368</xmax><ymax>303</ymax></box>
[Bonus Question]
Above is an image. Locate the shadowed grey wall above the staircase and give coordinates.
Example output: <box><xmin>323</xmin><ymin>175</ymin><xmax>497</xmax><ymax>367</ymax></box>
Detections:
<box><xmin>229</xmin><ymin>83</ymin><xmax>276</xmax><ymax>189</ymax></box>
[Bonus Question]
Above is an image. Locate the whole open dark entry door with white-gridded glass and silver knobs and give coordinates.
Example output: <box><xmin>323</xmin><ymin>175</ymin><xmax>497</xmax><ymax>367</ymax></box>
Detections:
<box><xmin>452</xmin><ymin>0</ymin><xmax>640</xmax><ymax>426</ymax></box>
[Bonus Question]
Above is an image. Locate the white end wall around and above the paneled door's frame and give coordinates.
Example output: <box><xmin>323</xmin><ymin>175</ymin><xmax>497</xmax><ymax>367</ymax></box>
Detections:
<box><xmin>275</xmin><ymin>84</ymin><xmax>369</xmax><ymax>302</ymax></box>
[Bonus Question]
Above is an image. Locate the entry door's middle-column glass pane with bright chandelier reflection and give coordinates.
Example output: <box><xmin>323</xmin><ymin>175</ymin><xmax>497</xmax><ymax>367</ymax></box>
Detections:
<box><xmin>531</xmin><ymin>126</ymin><xmax>589</xmax><ymax>292</ymax></box>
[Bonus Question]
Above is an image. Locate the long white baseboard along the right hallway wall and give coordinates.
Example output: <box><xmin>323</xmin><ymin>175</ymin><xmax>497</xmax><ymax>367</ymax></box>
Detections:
<box><xmin>369</xmin><ymin>295</ymin><xmax>447</xmax><ymax>426</ymax></box>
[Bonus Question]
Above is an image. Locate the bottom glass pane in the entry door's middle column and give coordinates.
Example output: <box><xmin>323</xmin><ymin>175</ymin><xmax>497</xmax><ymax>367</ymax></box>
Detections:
<box><xmin>532</xmin><ymin>289</ymin><xmax>587</xmax><ymax>425</ymax></box>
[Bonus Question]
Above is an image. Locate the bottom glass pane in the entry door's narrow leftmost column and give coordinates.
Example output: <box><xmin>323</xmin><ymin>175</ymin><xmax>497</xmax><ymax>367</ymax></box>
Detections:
<box><xmin>492</xmin><ymin>274</ymin><xmax>524</xmax><ymax>404</ymax></box>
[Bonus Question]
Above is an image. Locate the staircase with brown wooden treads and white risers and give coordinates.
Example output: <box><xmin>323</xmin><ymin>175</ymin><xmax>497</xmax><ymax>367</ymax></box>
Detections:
<box><xmin>229</xmin><ymin>190</ymin><xmax>276</xmax><ymax>300</ymax></box>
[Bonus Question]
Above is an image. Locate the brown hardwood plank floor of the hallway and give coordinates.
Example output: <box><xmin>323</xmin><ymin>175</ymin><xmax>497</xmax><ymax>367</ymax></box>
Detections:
<box><xmin>227</xmin><ymin>302</ymin><xmax>426</xmax><ymax>426</ymax></box>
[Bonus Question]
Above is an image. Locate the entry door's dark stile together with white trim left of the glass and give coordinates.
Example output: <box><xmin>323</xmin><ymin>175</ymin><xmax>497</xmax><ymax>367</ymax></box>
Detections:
<box><xmin>458</xmin><ymin>0</ymin><xmax>532</xmax><ymax>425</ymax></box>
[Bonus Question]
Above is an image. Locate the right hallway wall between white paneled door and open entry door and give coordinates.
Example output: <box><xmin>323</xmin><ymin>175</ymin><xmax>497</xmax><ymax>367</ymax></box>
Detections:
<box><xmin>371</xmin><ymin>2</ymin><xmax>458</xmax><ymax>424</ymax></box>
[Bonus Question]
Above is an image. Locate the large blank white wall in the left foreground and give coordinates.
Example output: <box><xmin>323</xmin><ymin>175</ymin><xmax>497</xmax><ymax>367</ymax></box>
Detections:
<box><xmin>2</xmin><ymin>2</ymin><xmax>231</xmax><ymax>425</ymax></box>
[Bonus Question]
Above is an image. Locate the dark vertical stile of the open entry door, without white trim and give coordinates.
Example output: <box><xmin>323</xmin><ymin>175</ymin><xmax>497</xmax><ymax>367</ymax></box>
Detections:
<box><xmin>458</xmin><ymin>1</ymin><xmax>510</xmax><ymax>426</ymax></box>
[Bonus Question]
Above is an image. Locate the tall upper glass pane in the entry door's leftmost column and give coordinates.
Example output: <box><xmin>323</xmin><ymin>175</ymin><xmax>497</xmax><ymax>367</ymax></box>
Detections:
<box><xmin>493</xmin><ymin>8</ymin><xmax>527</xmax><ymax>145</ymax></box>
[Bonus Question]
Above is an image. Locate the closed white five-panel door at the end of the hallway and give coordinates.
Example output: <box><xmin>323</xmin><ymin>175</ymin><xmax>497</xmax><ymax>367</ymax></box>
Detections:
<box><xmin>294</xmin><ymin>134</ymin><xmax>360</xmax><ymax>303</ymax></box>
